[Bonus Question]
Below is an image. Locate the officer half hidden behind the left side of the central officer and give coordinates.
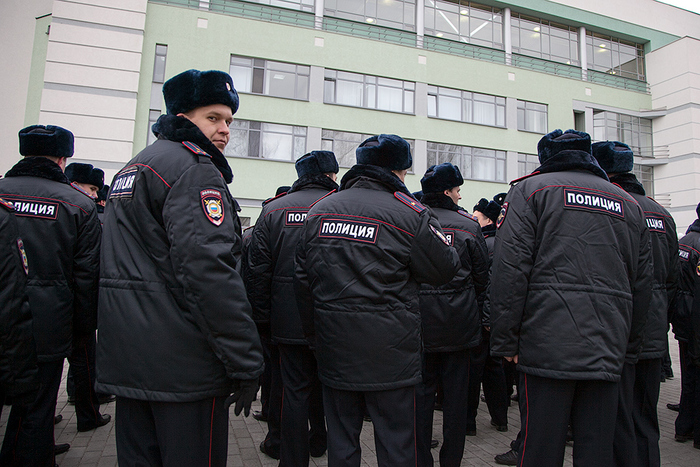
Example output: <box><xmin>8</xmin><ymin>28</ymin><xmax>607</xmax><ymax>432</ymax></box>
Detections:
<box><xmin>247</xmin><ymin>151</ymin><xmax>339</xmax><ymax>466</ymax></box>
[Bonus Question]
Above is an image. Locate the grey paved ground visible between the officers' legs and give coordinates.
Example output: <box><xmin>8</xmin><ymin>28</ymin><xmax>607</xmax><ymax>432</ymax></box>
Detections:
<box><xmin>0</xmin><ymin>339</ymin><xmax>700</xmax><ymax>467</ymax></box>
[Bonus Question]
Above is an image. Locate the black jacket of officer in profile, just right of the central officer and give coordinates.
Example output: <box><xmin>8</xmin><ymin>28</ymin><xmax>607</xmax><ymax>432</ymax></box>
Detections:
<box><xmin>420</xmin><ymin>193</ymin><xmax>489</xmax><ymax>352</ymax></box>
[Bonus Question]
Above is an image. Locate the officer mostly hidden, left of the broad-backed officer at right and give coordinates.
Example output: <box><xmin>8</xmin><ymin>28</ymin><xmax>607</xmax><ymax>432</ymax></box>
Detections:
<box><xmin>467</xmin><ymin>193</ymin><xmax>509</xmax><ymax>436</ymax></box>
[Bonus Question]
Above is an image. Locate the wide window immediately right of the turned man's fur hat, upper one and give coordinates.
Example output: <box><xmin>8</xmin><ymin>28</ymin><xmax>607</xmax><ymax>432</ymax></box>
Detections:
<box><xmin>229</xmin><ymin>55</ymin><xmax>311</xmax><ymax>100</ymax></box>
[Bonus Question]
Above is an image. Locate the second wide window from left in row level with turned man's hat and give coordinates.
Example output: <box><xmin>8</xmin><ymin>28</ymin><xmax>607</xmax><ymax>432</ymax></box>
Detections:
<box><xmin>323</xmin><ymin>70</ymin><xmax>416</xmax><ymax>113</ymax></box>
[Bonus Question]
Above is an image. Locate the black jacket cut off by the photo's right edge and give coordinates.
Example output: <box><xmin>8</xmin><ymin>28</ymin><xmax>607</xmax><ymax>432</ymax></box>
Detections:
<box><xmin>671</xmin><ymin>219</ymin><xmax>700</xmax><ymax>342</ymax></box>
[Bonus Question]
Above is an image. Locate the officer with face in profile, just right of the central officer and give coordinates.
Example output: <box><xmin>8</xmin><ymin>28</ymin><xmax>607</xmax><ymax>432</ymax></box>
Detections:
<box><xmin>416</xmin><ymin>162</ymin><xmax>489</xmax><ymax>467</ymax></box>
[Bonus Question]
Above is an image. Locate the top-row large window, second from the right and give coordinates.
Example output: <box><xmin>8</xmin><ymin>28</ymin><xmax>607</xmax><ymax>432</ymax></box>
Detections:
<box><xmin>511</xmin><ymin>13</ymin><xmax>581</xmax><ymax>66</ymax></box>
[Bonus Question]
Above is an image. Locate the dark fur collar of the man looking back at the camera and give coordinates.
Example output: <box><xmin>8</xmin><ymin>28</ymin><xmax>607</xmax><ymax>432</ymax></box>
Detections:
<box><xmin>151</xmin><ymin>114</ymin><xmax>233</xmax><ymax>183</ymax></box>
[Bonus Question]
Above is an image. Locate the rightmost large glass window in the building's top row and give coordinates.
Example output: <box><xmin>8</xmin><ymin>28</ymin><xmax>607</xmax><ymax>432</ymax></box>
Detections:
<box><xmin>586</xmin><ymin>31</ymin><xmax>645</xmax><ymax>81</ymax></box>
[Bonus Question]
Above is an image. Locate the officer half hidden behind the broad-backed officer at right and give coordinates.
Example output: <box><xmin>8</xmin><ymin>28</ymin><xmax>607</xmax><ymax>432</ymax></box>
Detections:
<box><xmin>593</xmin><ymin>141</ymin><xmax>678</xmax><ymax>467</ymax></box>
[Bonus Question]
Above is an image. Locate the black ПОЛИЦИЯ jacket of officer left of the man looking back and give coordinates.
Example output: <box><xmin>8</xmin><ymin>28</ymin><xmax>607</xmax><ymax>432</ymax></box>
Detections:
<box><xmin>0</xmin><ymin>157</ymin><xmax>101</xmax><ymax>362</ymax></box>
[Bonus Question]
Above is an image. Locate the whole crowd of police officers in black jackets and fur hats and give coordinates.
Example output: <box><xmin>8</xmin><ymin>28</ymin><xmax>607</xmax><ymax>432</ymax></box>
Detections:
<box><xmin>0</xmin><ymin>66</ymin><xmax>700</xmax><ymax>467</ymax></box>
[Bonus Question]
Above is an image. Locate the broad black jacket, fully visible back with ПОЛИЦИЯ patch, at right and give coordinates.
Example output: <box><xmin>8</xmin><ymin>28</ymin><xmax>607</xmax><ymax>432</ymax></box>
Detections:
<box><xmin>490</xmin><ymin>150</ymin><xmax>653</xmax><ymax>381</ymax></box>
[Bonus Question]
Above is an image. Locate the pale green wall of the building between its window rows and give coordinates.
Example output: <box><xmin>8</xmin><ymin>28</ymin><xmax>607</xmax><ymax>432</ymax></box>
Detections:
<box><xmin>134</xmin><ymin>1</ymin><xmax>660</xmax><ymax>221</ymax></box>
